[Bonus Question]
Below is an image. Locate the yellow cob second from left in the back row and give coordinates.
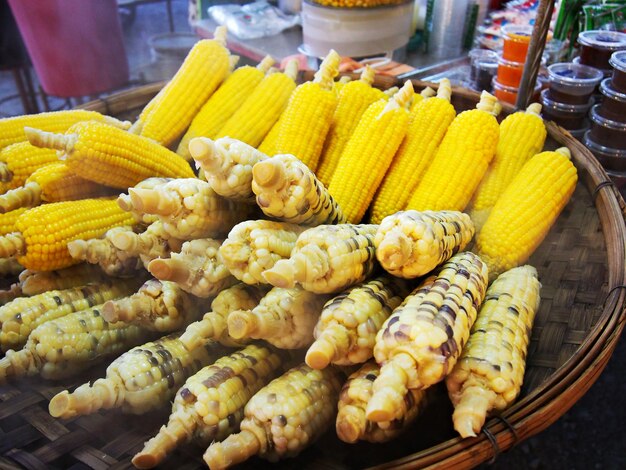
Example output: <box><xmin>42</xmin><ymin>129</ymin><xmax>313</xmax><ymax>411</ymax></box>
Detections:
<box><xmin>176</xmin><ymin>56</ymin><xmax>274</xmax><ymax>160</ymax></box>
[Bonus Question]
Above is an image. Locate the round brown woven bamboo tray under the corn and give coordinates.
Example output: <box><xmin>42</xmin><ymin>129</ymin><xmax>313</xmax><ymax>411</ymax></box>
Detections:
<box><xmin>0</xmin><ymin>78</ymin><xmax>626</xmax><ymax>469</ymax></box>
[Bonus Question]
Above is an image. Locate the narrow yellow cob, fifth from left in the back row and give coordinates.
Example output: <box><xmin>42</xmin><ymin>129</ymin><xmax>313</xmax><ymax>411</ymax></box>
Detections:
<box><xmin>315</xmin><ymin>66</ymin><xmax>383</xmax><ymax>187</ymax></box>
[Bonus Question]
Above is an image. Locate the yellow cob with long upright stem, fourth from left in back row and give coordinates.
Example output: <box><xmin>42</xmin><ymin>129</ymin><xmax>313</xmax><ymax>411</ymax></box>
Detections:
<box><xmin>268</xmin><ymin>50</ymin><xmax>341</xmax><ymax>171</ymax></box>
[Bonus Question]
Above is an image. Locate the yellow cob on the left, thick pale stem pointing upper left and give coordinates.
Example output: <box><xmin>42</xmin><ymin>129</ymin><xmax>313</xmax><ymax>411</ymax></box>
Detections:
<box><xmin>26</xmin><ymin>121</ymin><xmax>193</xmax><ymax>190</ymax></box>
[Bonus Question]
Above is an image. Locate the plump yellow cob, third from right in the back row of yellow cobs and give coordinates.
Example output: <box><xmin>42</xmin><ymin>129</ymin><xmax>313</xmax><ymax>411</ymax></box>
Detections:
<box><xmin>406</xmin><ymin>91</ymin><xmax>501</xmax><ymax>211</ymax></box>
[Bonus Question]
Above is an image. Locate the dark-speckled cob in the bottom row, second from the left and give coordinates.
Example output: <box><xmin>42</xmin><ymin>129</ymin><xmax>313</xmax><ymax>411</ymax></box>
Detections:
<box><xmin>133</xmin><ymin>344</ymin><xmax>282</xmax><ymax>468</ymax></box>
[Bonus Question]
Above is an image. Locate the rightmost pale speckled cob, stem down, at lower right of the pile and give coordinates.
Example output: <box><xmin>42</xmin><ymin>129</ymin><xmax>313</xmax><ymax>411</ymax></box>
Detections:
<box><xmin>446</xmin><ymin>265</ymin><xmax>541</xmax><ymax>437</ymax></box>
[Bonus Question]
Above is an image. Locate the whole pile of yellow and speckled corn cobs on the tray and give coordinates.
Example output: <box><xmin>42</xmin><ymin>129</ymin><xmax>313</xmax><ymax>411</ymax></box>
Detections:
<box><xmin>0</xmin><ymin>31</ymin><xmax>577</xmax><ymax>468</ymax></box>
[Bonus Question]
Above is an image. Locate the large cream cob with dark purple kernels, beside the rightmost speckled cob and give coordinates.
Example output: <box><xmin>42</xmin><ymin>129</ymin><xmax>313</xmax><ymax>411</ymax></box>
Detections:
<box><xmin>367</xmin><ymin>252</ymin><xmax>488</xmax><ymax>422</ymax></box>
